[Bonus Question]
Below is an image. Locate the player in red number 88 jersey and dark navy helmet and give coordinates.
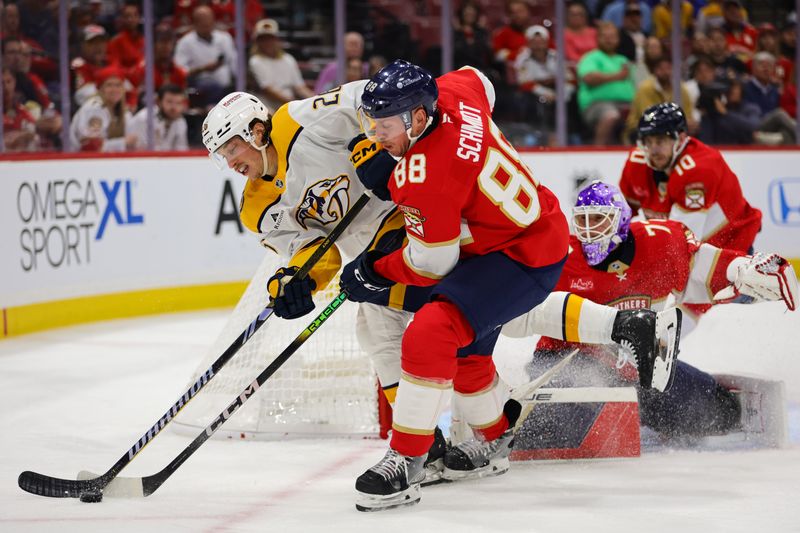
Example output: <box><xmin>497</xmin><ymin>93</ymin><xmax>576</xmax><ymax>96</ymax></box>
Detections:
<box><xmin>341</xmin><ymin>61</ymin><xmax>676</xmax><ymax>511</ymax></box>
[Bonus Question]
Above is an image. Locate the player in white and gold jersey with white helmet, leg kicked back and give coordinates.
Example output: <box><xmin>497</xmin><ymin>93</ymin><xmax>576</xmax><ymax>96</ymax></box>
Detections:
<box><xmin>203</xmin><ymin>80</ymin><xmax>680</xmax><ymax>498</ymax></box>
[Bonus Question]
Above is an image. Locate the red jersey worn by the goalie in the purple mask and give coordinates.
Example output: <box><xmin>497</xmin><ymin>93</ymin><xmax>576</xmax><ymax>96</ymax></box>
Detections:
<box><xmin>537</xmin><ymin>220</ymin><xmax>744</xmax><ymax>360</ymax></box>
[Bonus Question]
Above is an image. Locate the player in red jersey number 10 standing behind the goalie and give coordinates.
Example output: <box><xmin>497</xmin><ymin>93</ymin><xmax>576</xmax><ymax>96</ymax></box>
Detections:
<box><xmin>619</xmin><ymin>102</ymin><xmax>761</xmax><ymax>252</ymax></box>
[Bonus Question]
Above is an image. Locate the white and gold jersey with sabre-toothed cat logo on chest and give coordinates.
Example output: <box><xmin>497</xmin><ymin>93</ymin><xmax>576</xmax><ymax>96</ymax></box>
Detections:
<box><xmin>240</xmin><ymin>80</ymin><xmax>393</xmax><ymax>288</ymax></box>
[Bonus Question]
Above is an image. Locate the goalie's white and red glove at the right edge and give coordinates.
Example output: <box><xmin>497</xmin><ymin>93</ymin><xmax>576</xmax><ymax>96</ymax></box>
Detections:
<box><xmin>714</xmin><ymin>253</ymin><xmax>798</xmax><ymax>311</ymax></box>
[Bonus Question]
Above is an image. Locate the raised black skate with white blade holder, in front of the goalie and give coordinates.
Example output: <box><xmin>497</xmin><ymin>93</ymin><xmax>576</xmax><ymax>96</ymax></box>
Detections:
<box><xmin>611</xmin><ymin>307</ymin><xmax>681</xmax><ymax>392</ymax></box>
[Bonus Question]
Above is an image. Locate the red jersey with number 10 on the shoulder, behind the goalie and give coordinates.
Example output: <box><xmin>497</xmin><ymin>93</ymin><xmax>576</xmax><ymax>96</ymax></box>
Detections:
<box><xmin>619</xmin><ymin>138</ymin><xmax>761</xmax><ymax>252</ymax></box>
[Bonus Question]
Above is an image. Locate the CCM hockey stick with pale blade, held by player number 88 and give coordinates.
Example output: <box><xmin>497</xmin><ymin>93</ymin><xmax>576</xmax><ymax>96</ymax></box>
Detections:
<box><xmin>71</xmin><ymin>291</ymin><xmax>347</xmax><ymax>498</ymax></box>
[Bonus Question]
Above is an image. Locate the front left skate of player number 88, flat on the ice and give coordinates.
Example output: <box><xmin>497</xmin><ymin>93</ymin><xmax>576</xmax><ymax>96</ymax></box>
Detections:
<box><xmin>356</xmin><ymin>449</ymin><xmax>427</xmax><ymax>512</ymax></box>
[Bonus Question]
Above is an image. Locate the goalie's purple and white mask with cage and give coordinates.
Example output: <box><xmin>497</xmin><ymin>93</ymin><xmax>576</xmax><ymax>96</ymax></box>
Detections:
<box><xmin>572</xmin><ymin>181</ymin><xmax>631</xmax><ymax>266</ymax></box>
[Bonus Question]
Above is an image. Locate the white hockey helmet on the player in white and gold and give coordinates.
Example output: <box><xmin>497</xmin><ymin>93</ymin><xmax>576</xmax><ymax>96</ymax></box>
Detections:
<box><xmin>203</xmin><ymin>92</ymin><xmax>271</xmax><ymax>168</ymax></box>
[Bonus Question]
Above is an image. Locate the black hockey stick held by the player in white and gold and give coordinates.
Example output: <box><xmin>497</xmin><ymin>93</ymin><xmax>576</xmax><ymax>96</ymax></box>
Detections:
<box><xmin>17</xmin><ymin>193</ymin><xmax>370</xmax><ymax>498</ymax></box>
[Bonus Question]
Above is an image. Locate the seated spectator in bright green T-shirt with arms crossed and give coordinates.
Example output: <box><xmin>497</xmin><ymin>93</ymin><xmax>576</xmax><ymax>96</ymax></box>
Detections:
<box><xmin>578</xmin><ymin>22</ymin><xmax>635</xmax><ymax>145</ymax></box>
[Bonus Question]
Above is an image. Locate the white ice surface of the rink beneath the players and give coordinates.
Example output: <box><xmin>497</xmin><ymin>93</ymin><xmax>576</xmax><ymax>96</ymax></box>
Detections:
<box><xmin>0</xmin><ymin>304</ymin><xmax>800</xmax><ymax>533</ymax></box>
